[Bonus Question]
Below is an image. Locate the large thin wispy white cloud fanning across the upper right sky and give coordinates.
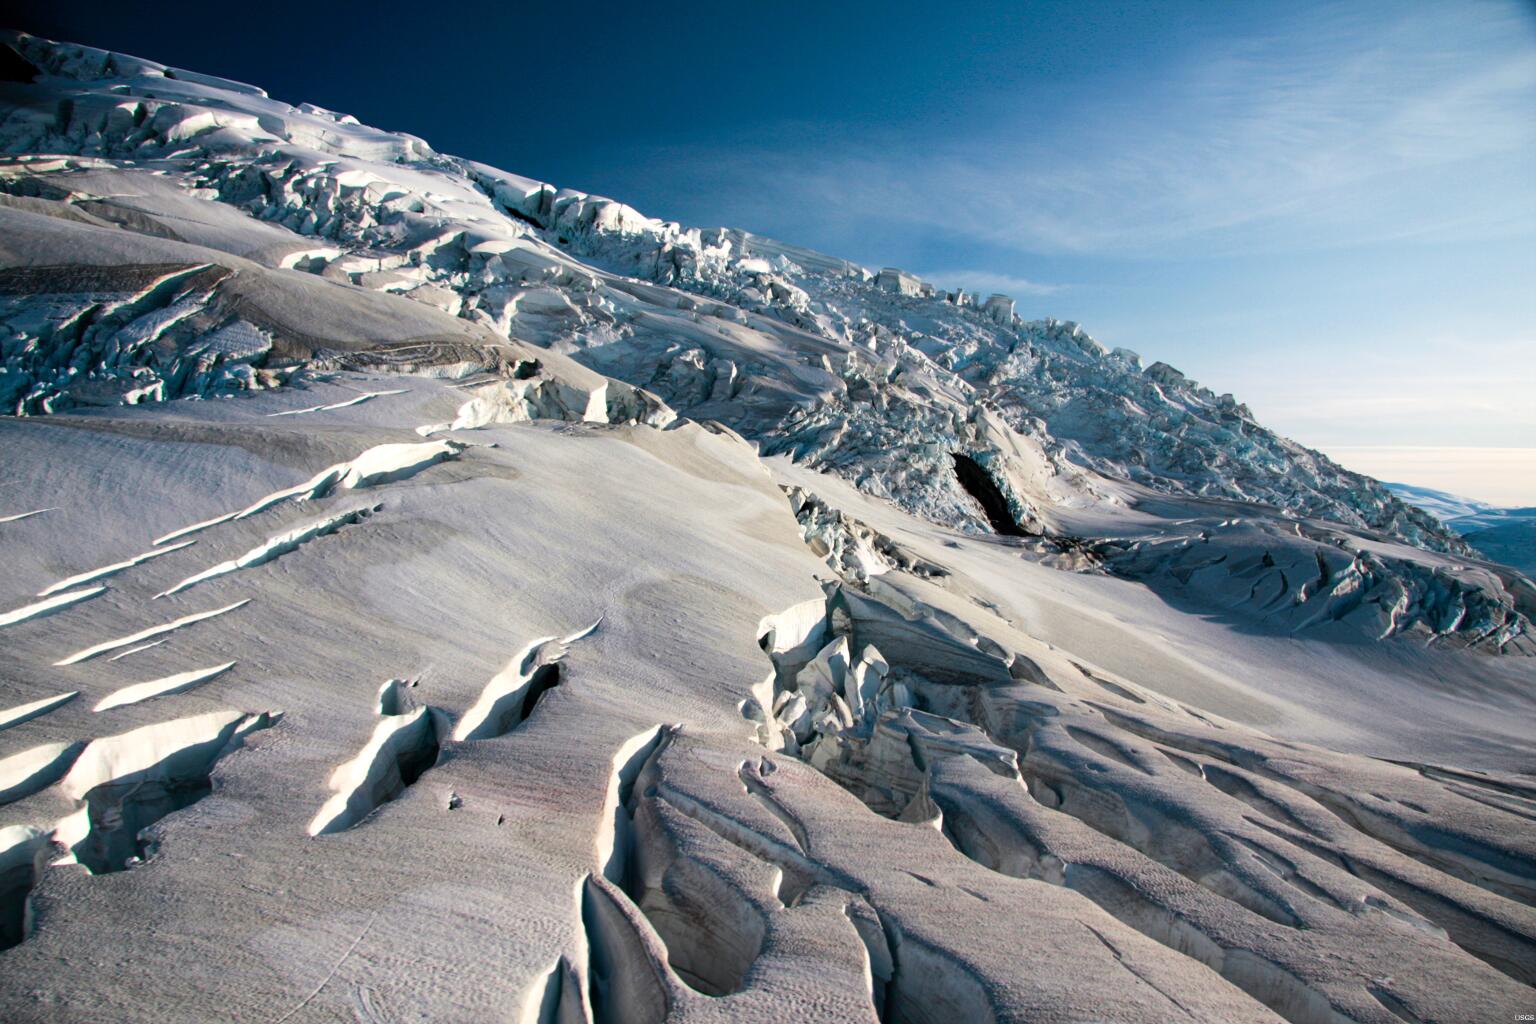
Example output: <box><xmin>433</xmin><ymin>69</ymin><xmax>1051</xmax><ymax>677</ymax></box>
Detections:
<box><xmin>635</xmin><ymin>5</ymin><xmax>1536</xmax><ymax>255</ymax></box>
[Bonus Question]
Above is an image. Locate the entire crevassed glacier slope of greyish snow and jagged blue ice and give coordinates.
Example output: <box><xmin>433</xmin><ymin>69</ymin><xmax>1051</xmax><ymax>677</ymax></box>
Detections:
<box><xmin>0</xmin><ymin>34</ymin><xmax>1536</xmax><ymax>1024</ymax></box>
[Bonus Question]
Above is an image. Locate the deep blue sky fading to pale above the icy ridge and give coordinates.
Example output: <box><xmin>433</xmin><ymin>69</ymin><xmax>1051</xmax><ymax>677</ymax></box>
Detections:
<box><xmin>26</xmin><ymin>0</ymin><xmax>1536</xmax><ymax>504</ymax></box>
